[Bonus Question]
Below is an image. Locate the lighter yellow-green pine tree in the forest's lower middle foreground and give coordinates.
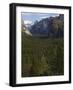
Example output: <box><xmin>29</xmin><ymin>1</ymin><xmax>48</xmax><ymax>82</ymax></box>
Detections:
<box><xmin>32</xmin><ymin>55</ymin><xmax>48</xmax><ymax>76</ymax></box>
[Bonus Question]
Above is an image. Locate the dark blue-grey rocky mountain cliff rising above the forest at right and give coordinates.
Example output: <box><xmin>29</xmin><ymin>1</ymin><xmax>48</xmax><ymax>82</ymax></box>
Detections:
<box><xmin>30</xmin><ymin>14</ymin><xmax>64</xmax><ymax>37</ymax></box>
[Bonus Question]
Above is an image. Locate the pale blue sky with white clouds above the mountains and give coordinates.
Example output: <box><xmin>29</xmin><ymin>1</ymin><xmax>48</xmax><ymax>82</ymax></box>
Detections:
<box><xmin>21</xmin><ymin>12</ymin><xmax>59</xmax><ymax>24</ymax></box>
